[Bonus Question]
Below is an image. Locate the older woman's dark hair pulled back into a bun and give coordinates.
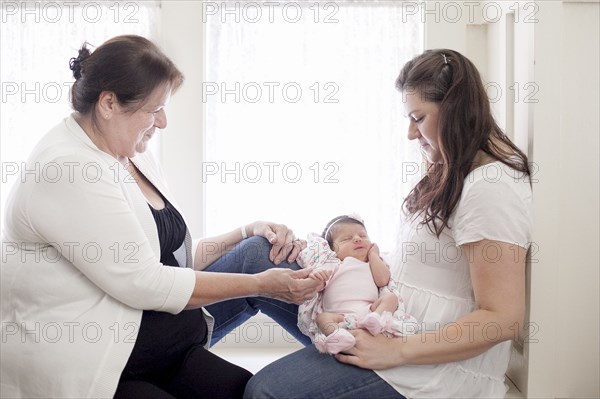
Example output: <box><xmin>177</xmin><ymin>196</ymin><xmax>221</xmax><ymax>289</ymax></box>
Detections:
<box><xmin>69</xmin><ymin>35</ymin><xmax>183</xmax><ymax>121</ymax></box>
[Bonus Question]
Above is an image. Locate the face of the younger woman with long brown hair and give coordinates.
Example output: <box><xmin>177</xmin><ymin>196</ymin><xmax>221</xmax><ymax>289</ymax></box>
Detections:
<box><xmin>403</xmin><ymin>91</ymin><xmax>442</xmax><ymax>163</ymax></box>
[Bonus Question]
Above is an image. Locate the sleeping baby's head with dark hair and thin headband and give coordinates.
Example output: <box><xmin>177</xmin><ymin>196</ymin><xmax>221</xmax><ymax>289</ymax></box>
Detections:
<box><xmin>321</xmin><ymin>215</ymin><xmax>371</xmax><ymax>262</ymax></box>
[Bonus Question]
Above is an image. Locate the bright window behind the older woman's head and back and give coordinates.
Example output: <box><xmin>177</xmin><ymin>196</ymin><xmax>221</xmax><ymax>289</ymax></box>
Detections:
<box><xmin>0</xmin><ymin>1</ymin><xmax>158</xmax><ymax>220</ymax></box>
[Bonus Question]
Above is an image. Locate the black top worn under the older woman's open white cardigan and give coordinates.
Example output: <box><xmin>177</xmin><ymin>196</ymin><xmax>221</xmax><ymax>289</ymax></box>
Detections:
<box><xmin>121</xmin><ymin>197</ymin><xmax>208</xmax><ymax>379</ymax></box>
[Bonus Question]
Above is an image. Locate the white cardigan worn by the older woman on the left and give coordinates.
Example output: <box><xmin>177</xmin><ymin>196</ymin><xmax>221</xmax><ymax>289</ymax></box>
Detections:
<box><xmin>0</xmin><ymin>116</ymin><xmax>213</xmax><ymax>398</ymax></box>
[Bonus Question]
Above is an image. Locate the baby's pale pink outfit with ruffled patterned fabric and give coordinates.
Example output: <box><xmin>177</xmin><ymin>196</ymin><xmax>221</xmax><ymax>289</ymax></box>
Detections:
<box><xmin>298</xmin><ymin>234</ymin><xmax>418</xmax><ymax>348</ymax></box>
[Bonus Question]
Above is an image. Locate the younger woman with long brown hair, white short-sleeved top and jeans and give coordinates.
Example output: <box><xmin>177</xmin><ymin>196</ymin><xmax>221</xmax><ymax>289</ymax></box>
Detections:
<box><xmin>245</xmin><ymin>50</ymin><xmax>533</xmax><ymax>399</ymax></box>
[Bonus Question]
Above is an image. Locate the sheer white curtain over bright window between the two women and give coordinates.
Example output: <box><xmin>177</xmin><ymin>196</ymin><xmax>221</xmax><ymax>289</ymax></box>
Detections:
<box><xmin>203</xmin><ymin>1</ymin><xmax>423</xmax><ymax>251</ymax></box>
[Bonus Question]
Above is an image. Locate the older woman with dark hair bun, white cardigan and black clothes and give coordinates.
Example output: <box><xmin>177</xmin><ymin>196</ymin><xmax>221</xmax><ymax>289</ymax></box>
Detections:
<box><xmin>1</xmin><ymin>36</ymin><xmax>319</xmax><ymax>398</ymax></box>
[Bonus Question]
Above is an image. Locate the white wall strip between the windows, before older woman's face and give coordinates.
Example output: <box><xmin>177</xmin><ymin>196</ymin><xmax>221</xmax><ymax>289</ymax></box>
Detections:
<box><xmin>159</xmin><ymin>0</ymin><xmax>204</xmax><ymax>238</ymax></box>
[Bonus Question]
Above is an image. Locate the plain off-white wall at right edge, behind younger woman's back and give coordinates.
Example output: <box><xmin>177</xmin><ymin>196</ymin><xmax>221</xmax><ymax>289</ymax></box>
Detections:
<box><xmin>529</xmin><ymin>1</ymin><xmax>600</xmax><ymax>398</ymax></box>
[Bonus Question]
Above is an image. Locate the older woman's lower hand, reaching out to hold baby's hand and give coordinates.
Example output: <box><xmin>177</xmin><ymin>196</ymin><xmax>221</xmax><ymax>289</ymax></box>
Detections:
<box><xmin>255</xmin><ymin>268</ymin><xmax>325</xmax><ymax>305</ymax></box>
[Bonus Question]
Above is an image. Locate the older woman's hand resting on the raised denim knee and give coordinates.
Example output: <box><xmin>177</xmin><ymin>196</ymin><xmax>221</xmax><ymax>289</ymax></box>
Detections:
<box><xmin>251</xmin><ymin>221</ymin><xmax>306</xmax><ymax>265</ymax></box>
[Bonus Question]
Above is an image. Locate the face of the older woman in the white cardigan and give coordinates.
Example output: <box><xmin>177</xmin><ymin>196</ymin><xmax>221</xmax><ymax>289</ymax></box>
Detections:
<box><xmin>112</xmin><ymin>84</ymin><xmax>171</xmax><ymax>157</ymax></box>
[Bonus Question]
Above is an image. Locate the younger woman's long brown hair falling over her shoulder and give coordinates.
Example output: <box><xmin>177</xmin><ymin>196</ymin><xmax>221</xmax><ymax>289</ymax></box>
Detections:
<box><xmin>396</xmin><ymin>49</ymin><xmax>530</xmax><ymax>237</ymax></box>
